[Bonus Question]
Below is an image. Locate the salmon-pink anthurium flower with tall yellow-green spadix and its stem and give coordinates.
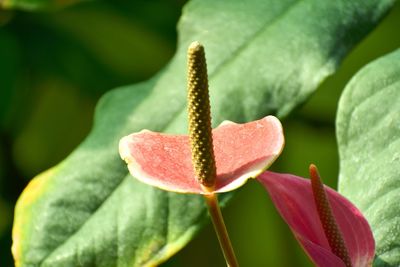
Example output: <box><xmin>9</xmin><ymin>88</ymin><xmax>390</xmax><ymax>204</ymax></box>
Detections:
<box><xmin>119</xmin><ymin>42</ymin><xmax>284</xmax><ymax>267</ymax></box>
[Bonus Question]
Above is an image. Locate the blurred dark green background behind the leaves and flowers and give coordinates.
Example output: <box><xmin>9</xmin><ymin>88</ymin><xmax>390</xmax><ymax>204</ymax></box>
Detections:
<box><xmin>0</xmin><ymin>0</ymin><xmax>400</xmax><ymax>267</ymax></box>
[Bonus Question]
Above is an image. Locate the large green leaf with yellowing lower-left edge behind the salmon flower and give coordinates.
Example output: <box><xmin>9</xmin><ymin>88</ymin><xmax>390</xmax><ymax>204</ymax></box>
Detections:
<box><xmin>13</xmin><ymin>0</ymin><xmax>393</xmax><ymax>266</ymax></box>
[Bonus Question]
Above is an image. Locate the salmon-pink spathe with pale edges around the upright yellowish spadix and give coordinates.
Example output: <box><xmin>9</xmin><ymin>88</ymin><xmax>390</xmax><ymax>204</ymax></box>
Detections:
<box><xmin>119</xmin><ymin>116</ymin><xmax>284</xmax><ymax>194</ymax></box>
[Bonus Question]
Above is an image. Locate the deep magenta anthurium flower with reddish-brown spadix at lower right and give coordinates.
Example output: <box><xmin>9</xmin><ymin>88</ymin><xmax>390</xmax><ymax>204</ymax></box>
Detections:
<box><xmin>257</xmin><ymin>165</ymin><xmax>375</xmax><ymax>267</ymax></box>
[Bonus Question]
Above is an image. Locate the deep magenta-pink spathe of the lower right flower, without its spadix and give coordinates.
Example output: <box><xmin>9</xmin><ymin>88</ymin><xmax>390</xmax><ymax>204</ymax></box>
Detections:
<box><xmin>257</xmin><ymin>172</ymin><xmax>375</xmax><ymax>267</ymax></box>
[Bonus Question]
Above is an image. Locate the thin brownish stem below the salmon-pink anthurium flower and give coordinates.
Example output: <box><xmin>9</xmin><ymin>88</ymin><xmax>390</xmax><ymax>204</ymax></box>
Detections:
<box><xmin>204</xmin><ymin>193</ymin><xmax>239</xmax><ymax>267</ymax></box>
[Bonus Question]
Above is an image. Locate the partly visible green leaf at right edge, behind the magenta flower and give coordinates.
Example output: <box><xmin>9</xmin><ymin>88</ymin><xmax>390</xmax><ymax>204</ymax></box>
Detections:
<box><xmin>337</xmin><ymin>50</ymin><xmax>400</xmax><ymax>266</ymax></box>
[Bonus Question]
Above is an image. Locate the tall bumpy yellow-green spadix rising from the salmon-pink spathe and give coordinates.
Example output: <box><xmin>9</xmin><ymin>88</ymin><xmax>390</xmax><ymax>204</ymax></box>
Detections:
<box><xmin>188</xmin><ymin>42</ymin><xmax>217</xmax><ymax>188</ymax></box>
